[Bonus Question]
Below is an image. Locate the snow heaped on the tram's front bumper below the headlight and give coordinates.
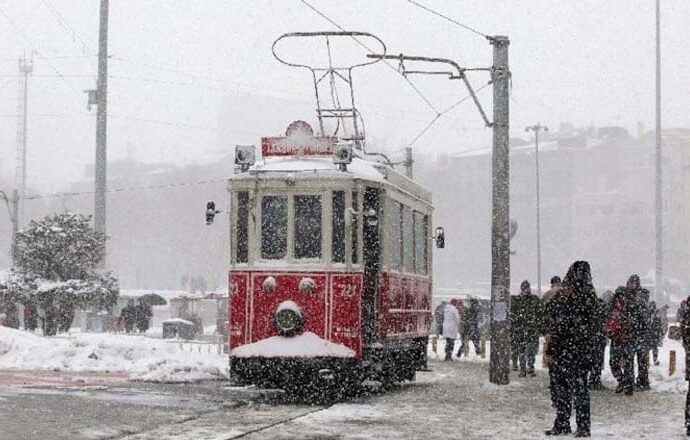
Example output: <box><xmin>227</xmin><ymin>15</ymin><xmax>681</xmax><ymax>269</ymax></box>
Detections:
<box><xmin>231</xmin><ymin>332</ymin><xmax>355</xmax><ymax>358</ymax></box>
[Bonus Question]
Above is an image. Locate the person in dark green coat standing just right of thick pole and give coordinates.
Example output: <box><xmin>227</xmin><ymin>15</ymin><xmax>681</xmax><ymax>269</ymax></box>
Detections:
<box><xmin>510</xmin><ymin>280</ymin><xmax>544</xmax><ymax>377</ymax></box>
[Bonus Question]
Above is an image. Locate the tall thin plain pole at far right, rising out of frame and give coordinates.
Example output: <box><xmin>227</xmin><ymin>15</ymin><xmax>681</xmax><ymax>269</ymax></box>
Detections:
<box><xmin>654</xmin><ymin>0</ymin><xmax>664</xmax><ymax>300</ymax></box>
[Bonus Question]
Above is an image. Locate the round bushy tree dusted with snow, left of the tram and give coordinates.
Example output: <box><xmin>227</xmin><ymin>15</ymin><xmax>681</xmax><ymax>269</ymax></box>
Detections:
<box><xmin>0</xmin><ymin>213</ymin><xmax>119</xmax><ymax>335</ymax></box>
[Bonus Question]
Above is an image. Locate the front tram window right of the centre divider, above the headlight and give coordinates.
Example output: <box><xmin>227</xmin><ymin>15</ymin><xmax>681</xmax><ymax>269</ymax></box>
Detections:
<box><xmin>294</xmin><ymin>195</ymin><xmax>322</xmax><ymax>259</ymax></box>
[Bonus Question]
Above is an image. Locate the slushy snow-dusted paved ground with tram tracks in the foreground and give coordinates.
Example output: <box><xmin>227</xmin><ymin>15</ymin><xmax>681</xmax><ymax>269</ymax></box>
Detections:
<box><xmin>0</xmin><ymin>361</ymin><xmax>685</xmax><ymax>440</ymax></box>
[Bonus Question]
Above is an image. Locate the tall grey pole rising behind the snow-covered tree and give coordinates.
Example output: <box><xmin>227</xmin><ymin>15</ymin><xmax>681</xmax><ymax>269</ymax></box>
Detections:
<box><xmin>94</xmin><ymin>0</ymin><xmax>109</xmax><ymax>266</ymax></box>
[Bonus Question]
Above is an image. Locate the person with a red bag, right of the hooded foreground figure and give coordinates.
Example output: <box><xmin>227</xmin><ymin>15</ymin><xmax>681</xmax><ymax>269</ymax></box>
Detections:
<box><xmin>606</xmin><ymin>286</ymin><xmax>637</xmax><ymax>396</ymax></box>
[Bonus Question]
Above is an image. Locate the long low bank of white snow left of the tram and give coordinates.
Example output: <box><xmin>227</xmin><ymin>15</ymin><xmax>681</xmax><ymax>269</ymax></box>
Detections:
<box><xmin>0</xmin><ymin>327</ymin><xmax>228</xmax><ymax>382</ymax></box>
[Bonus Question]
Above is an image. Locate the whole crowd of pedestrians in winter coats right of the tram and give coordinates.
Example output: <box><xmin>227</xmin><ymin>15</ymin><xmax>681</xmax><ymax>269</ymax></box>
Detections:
<box><xmin>434</xmin><ymin>261</ymin><xmax>690</xmax><ymax>437</ymax></box>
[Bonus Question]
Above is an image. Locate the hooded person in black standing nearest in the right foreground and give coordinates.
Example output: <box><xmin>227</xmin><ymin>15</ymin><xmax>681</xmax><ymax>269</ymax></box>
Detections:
<box><xmin>546</xmin><ymin>261</ymin><xmax>597</xmax><ymax>437</ymax></box>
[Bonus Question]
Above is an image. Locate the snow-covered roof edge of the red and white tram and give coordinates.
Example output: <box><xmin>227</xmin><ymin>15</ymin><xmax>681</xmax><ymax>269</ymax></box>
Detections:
<box><xmin>229</xmin><ymin>156</ymin><xmax>431</xmax><ymax>202</ymax></box>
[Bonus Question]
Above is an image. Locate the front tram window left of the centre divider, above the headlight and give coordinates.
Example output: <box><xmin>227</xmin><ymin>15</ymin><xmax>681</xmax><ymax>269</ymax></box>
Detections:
<box><xmin>261</xmin><ymin>196</ymin><xmax>287</xmax><ymax>260</ymax></box>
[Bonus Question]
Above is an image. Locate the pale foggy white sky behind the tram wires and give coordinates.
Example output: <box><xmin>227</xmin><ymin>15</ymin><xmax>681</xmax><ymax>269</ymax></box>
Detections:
<box><xmin>0</xmin><ymin>0</ymin><xmax>690</xmax><ymax>192</ymax></box>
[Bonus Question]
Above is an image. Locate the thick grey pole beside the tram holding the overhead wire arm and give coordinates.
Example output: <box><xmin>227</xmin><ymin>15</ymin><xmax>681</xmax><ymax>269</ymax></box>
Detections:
<box><xmin>489</xmin><ymin>35</ymin><xmax>510</xmax><ymax>385</ymax></box>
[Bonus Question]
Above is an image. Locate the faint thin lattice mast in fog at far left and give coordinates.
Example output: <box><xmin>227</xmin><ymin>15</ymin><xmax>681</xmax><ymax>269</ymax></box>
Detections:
<box><xmin>11</xmin><ymin>55</ymin><xmax>34</xmax><ymax>263</ymax></box>
